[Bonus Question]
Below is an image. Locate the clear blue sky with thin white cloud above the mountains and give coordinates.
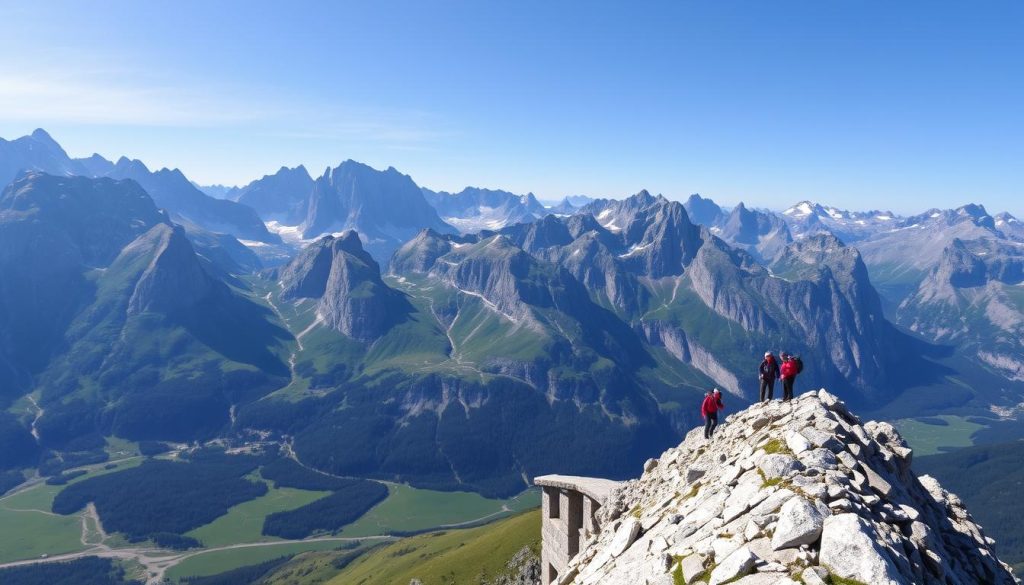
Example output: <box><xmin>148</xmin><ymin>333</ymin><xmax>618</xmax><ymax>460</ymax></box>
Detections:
<box><xmin>0</xmin><ymin>0</ymin><xmax>1024</xmax><ymax>216</ymax></box>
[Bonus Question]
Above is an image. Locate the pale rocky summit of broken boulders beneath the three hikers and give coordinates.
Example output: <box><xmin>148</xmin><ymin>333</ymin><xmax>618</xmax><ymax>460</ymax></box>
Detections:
<box><xmin>557</xmin><ymin>390</ymin><xmax>1018</xmax><ymax>585</ymax></box>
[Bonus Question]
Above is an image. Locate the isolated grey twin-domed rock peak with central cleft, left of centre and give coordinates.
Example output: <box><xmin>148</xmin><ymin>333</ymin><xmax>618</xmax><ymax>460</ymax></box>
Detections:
<box><xmin>281</xmin><ymin>231</ymin><xmax>409</xmax><ymax>341</ymax></box>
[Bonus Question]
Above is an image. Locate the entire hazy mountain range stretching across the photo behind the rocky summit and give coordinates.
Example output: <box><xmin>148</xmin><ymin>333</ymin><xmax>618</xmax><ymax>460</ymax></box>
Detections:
<box><xmin>0</xmin><ymin>127</ymin><xmax>1024</xmax><ymax>504</ymax></box>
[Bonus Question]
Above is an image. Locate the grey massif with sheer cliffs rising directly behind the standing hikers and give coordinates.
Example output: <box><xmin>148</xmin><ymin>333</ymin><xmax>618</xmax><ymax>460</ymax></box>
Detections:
<box><xmin>687</xmin><ymin>235</ymin><xmax>905</xmax><ymax>398</ymax></box>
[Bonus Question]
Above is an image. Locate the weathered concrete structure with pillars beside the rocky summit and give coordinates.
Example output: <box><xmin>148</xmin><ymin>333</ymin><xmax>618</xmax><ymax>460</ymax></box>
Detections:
<box><xmin>534</xmin><ymin>475</ymin><xmax>621</xmax><ymax>585</ymax></box>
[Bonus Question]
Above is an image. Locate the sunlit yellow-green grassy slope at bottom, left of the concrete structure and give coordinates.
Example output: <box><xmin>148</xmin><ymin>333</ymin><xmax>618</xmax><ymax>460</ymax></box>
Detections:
<box><xmin>321</xmin><ymin>510</ymin><xmax>541</xmax><ymax>585</ymax></box>
